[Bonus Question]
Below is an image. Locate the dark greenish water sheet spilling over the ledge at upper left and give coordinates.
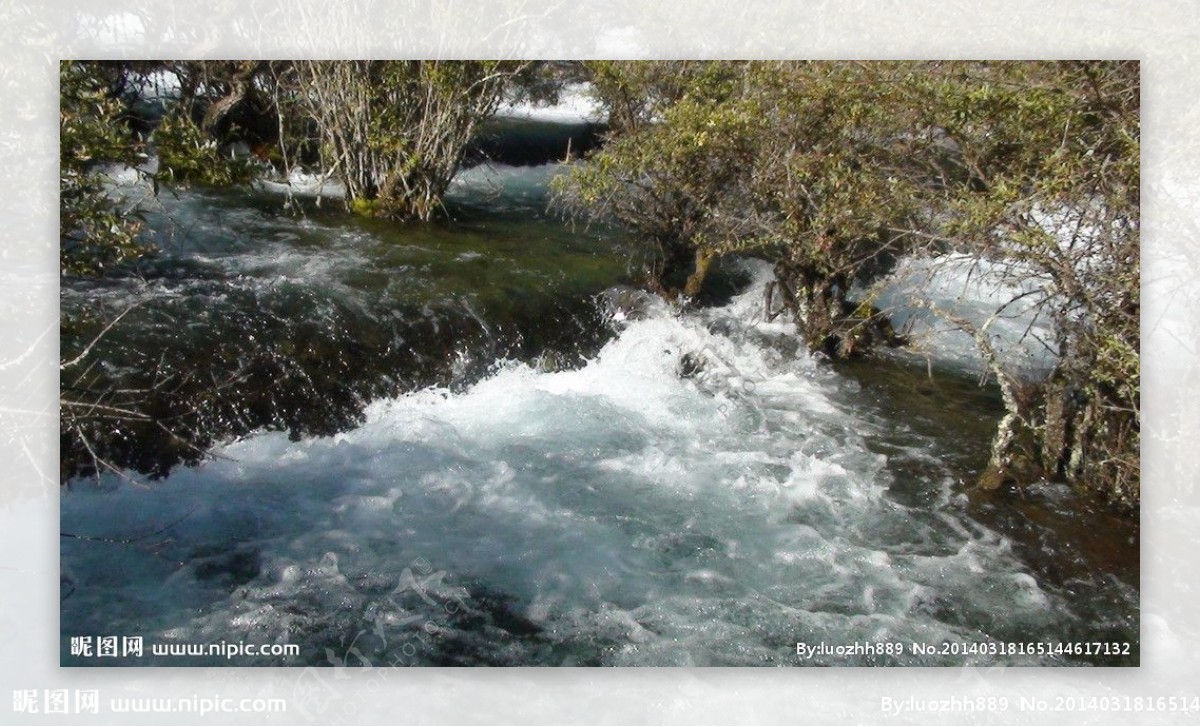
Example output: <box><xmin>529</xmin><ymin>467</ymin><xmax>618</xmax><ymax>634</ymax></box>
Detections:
<box><xmin>62</xmin><ymin>167</ymin><xmax>625</xmax><ymax>475</ymax></box>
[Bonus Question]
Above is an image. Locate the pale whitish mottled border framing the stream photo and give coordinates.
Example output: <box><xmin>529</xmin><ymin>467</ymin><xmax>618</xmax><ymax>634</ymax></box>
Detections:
<box><xmin>0</xmin><ymin>0</ymin><xmax>1200</xmax><ymax>723</ymax></box>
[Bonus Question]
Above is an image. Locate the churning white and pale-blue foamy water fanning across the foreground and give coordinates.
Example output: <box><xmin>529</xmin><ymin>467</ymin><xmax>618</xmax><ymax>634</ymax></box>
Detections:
<box><xmin>62</xmin><ymin>261</ymin><xmax>1104</xmax><ymax>663</ymax></box>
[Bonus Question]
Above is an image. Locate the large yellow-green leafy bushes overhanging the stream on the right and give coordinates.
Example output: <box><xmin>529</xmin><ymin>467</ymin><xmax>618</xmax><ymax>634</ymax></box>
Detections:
<box><xmin>557</xmin><ymin>61</ymin><xmax>1140</xmax><ymax>507</ymax></box>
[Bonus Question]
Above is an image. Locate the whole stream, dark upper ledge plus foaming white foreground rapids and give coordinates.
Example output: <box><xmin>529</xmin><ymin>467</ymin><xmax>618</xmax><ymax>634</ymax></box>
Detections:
<box><xmin>61</xmin><ymin>158</ymin><xmax>1138</xmax><ymax>666</ymax></box>
